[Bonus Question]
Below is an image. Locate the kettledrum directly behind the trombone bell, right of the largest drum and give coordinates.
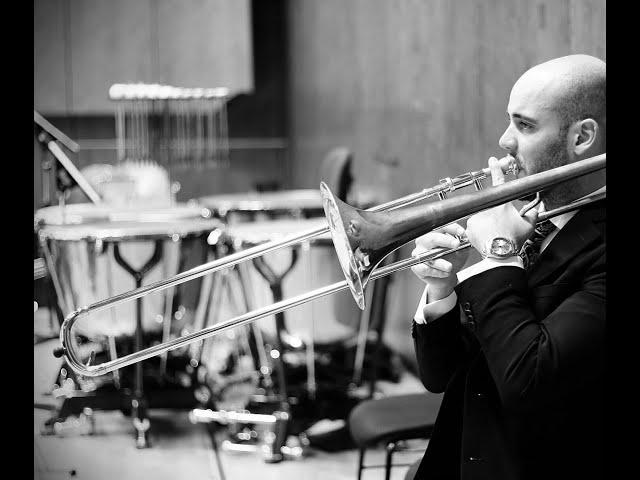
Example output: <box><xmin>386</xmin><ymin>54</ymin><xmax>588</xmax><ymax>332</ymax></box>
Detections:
<box><xmin>220</xmin><ymin>217</ymin><xmax>360</xmax><ymax>343</ymax></box>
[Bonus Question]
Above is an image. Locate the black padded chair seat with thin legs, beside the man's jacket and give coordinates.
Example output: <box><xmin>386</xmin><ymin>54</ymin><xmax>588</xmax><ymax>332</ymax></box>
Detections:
<box><xmin>349</xmin><ymin>392</ymin><xmax>442</xmax><ymax>480</ymax></box>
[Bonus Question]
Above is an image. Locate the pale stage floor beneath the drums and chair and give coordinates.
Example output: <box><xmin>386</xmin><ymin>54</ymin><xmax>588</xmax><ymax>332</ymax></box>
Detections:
<box><xmin>34</xmin><ymin>340</ymin><xmax>426</xmax><ymax>480</ymax></box>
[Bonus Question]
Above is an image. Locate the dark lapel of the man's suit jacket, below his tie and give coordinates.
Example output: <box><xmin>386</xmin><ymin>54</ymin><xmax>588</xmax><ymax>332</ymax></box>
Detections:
<box><xmin>529</xmin><ymin>202</ymin><xmax>606</xmax><ymax>287</ymax></box>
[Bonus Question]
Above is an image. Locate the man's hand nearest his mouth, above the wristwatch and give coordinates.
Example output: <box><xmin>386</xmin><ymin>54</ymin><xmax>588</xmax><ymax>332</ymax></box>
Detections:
<box><xmin>466</xmin><ymin>157</ymin><xmax>538</xmax><ymax>254</ymax></box>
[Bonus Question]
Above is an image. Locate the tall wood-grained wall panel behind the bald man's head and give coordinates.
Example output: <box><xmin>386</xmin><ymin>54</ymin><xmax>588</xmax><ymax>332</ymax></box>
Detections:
<box><xmin>289</xmin><ymin>0</ymin><xmax>606</xmax><ymax>360</ymax></box>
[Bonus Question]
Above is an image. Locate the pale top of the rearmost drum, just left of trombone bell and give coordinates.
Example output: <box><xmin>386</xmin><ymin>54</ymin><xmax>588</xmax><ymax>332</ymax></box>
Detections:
<box><xmin>198</xmin><ymin>189</ymin><xmax>324</xmax><ymax>223</ymax></box>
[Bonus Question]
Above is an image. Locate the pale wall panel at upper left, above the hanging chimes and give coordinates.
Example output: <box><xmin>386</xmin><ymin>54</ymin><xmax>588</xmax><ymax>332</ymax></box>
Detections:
<box><xmin>34</xmin><ymin>0</ymin><xmax>253</xmax><ymax>115</ymax></box>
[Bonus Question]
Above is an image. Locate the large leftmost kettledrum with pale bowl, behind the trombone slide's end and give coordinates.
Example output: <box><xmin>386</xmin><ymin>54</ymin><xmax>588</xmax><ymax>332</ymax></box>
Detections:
<box><xmin>35</xmin><ymin>204</ymin><xmax>222</xmax><ymax>339</ymax></box>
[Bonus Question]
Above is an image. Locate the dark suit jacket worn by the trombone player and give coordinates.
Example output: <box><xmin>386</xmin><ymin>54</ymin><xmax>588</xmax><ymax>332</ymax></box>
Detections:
<box><xmin>412</xmin><ymin>202</ymin><xmax>606</xmax><ymax>480</ymax></box>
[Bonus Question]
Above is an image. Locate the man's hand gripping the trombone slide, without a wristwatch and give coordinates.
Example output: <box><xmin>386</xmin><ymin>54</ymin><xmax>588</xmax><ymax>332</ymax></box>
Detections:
<box><xmin>411</xmin><ymin>223</ymin><xmax>469</xmax><ymax>302</ymax></box>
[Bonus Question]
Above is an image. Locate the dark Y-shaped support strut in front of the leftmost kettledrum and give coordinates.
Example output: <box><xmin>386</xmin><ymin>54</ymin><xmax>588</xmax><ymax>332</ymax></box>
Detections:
<box><xmin>113</xmin><ymin>240</ymin><xmax>162</xmax><ymax>448</ymax></box>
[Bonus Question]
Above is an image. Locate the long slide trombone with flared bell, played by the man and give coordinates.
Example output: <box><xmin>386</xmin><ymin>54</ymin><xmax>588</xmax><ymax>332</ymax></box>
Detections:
<box><xmin>54</xmin><ymin>154</ymin><xmax>606</xmax><ymax>377</ymax></box>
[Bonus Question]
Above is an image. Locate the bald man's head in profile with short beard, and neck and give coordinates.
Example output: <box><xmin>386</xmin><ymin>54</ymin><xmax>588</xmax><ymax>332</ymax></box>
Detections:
<box><xmin>499</xmin><ymin>55</ymin><xmax>606</xmax><ymax>208</ymax></box>
